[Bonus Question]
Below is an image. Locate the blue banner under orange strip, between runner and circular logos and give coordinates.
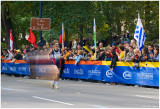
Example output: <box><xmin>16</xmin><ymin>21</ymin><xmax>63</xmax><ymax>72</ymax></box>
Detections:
<box><xmin>63</xmin><ymin>64</ymin><xmax>102</xmax><ymax>80</ymax></box>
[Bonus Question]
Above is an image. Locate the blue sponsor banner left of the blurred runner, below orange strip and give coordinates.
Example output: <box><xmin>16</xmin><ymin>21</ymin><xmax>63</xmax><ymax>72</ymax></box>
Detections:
<box><xmin>1</xmin><ymin>63</ymin><xmax>30</xmax><ymax>75</ymax></box>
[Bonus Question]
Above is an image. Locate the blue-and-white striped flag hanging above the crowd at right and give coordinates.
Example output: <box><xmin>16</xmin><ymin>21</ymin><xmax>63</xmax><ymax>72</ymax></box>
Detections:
<box><xmin>134</xmin><ymin>13</ymin><xmax>146</xmax><ymax>51</ymax></box>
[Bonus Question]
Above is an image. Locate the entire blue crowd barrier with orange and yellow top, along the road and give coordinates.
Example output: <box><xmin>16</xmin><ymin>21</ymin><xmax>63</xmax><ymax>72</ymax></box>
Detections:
<box><xmin>1</xmin><ymin>60</ymin><xmax>159</xmax><ymax>86</ymax></box>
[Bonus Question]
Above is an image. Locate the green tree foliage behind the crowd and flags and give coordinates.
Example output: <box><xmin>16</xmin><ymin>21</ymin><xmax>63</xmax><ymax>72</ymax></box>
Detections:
<box><xmin>2</xmin><ymin>1</ymin><xmax>159</xmax><ymax>46</ymax></box>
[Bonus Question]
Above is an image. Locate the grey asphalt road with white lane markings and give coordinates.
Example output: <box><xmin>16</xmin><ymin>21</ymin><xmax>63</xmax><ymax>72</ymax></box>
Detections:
<box><xmin>1</xmin><ymin>75</ymin><xmax>159</xmax><ymax>108</ymax></box>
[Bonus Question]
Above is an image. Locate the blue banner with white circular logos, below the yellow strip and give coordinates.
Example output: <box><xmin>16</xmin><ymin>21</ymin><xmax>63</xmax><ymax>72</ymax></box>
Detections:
<box><xmin>102</xmin><ymin>65</ymin><xmax>159</xmax><ymax>86</ymax></box>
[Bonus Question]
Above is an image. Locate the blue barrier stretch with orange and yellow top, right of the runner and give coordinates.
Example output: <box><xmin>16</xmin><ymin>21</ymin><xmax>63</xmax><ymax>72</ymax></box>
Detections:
<box><xmin>63</xmin><ymin>61</ymin><xmax>159</xmax><ymax>86</ymax></box>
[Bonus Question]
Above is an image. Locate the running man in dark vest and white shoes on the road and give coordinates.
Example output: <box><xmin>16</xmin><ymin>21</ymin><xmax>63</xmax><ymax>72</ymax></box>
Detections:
<box><xmin>49</xmin><ymin>40</ymin><xmax>63</xmax><ymax>89</ymax></box>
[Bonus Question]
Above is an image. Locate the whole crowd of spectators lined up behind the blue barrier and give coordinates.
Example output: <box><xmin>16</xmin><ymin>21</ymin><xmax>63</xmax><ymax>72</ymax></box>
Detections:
<box><xmin>1</xmin><ymin>32</ymin><xmax>159</xmax><ymax>67</ymax></box>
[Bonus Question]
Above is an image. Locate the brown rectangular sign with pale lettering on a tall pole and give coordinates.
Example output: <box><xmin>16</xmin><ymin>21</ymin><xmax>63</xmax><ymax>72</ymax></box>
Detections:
<box><xmin>31</xmin><ymin>18</ymin><xmax>51</xmax><ymax>30</ymax></box>
